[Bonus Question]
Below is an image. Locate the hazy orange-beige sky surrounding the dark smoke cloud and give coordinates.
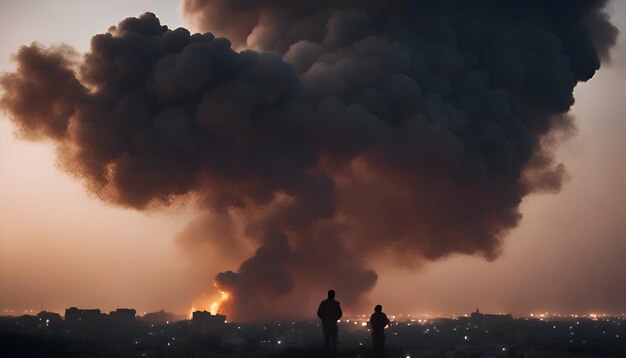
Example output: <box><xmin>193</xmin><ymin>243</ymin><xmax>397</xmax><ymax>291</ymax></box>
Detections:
<box><xmin>0</xmin><ymin>0</ymin><xmax>626</xmax><ymax>315</ymax></box>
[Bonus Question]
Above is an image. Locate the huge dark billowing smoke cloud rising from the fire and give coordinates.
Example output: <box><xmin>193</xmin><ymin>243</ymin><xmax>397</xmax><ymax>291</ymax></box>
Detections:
<box><xmin>1</xmin><ymin>0</ymin><xmax>617</xmax><ymax>321</ymax></box>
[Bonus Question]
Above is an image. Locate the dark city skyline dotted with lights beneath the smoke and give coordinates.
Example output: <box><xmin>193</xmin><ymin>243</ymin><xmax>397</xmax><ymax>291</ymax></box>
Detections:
<box><xmin>0</xmin><ymin>307</ymin><xmax>626</xmax><ymax>358</ymax></box>
